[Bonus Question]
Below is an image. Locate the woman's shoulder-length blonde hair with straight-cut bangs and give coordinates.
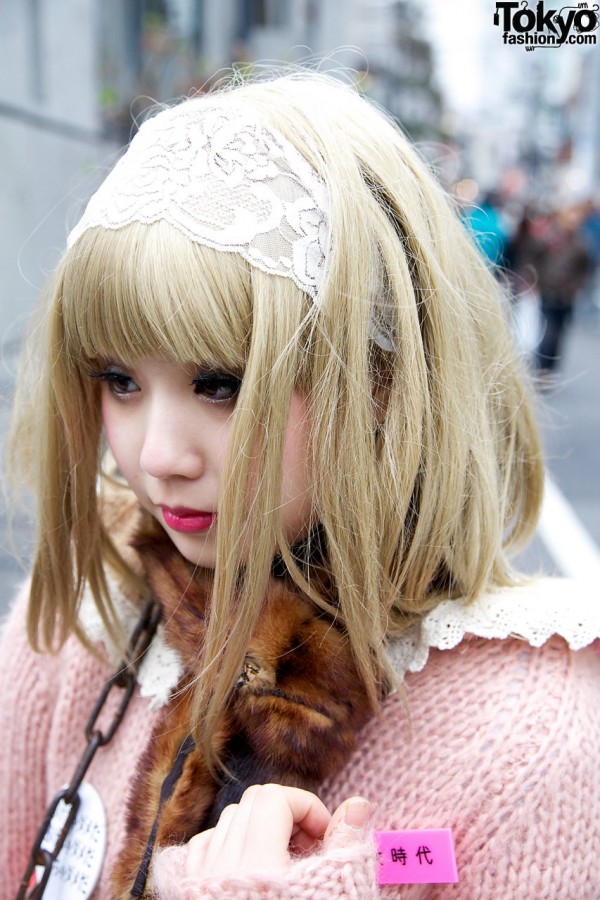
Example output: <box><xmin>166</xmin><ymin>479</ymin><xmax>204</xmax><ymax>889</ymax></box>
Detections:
<box><xmin>9</xmin><ymin>74</ymin><xmax>542</xmax><ymax>768</ymax></box>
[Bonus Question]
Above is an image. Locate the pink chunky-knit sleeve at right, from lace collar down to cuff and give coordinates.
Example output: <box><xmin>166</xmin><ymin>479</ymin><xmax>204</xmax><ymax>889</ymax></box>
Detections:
<box><xmin>153</xmin><ymin>637</ymin><xmax>600</xmax><ymax>900</ymax></box>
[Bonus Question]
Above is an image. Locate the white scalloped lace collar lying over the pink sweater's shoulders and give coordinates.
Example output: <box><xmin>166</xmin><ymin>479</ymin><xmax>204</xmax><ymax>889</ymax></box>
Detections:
<box><xmin>80</xmin><ymin>578</ymin><xmax>600</xmax><ymax>709</ymax></box>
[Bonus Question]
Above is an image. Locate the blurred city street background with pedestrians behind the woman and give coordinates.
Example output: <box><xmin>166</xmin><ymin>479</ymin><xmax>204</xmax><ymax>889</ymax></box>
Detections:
<box><xmin>0</xmin><ymin>0</ymin><xmax>600</xmax><ymax>609</ymax></box>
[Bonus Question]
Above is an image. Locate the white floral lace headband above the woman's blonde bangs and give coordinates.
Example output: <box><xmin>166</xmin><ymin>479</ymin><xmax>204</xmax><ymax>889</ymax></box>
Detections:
<box><xmin>68</xmin><ymin>98</ymin><xmax>329</xmax><ymax>300</ymax></box>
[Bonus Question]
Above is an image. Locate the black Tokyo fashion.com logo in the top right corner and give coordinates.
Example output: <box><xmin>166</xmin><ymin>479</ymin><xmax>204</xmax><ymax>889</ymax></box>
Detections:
<box><xmin>494</xmin><ymin>0</ymin><xmax>600</xmax><ymax>50</ymax></box>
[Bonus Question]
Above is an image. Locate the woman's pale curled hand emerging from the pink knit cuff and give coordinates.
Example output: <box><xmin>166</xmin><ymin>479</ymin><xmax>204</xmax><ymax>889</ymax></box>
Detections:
<box><xmin>186</xmin><ymin>784</ymin><xmax>369</xmax><ymax>878</ymax></box>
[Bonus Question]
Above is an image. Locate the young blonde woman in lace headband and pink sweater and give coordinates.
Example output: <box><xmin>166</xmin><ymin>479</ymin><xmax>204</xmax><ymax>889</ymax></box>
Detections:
<box><xmin>0</xmin><ymin>74</ymin><xmax>600</xmax><ymax>900</ymax></box>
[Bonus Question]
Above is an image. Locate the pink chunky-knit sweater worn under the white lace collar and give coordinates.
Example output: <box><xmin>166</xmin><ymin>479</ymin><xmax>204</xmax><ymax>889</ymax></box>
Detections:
<box><xmin>0</xmin><ymin>580</ymin><xmax>600</xmax><ymax>900</ymax></box>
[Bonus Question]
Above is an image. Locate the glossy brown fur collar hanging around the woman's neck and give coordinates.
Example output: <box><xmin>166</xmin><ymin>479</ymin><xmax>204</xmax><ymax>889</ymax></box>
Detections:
<box><xmin>113</xmin><ymin>521</ymin><xmax>371</xmax><ymax>900</ymax></box>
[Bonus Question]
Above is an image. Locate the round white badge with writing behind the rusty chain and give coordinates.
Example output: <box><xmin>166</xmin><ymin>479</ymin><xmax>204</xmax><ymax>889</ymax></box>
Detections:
<box><xmin>36</xmin><ymin>781</ymin><xmax>106</xmax><ymax>900</ymax></box>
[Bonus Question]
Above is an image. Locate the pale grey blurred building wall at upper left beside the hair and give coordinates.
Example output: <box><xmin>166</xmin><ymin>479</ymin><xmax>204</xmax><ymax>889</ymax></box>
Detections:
<box><xmin>0</xmin><ymin>0</ymin><xmax>111</xmax><ymax>351</ymax></box>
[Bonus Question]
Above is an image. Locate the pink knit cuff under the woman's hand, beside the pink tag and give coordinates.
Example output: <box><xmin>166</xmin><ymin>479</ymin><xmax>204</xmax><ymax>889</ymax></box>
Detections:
<box><xmin>153</xmin><ymin>825</ymin><xmax>379</xmax><ymax>900</ymax></box>
